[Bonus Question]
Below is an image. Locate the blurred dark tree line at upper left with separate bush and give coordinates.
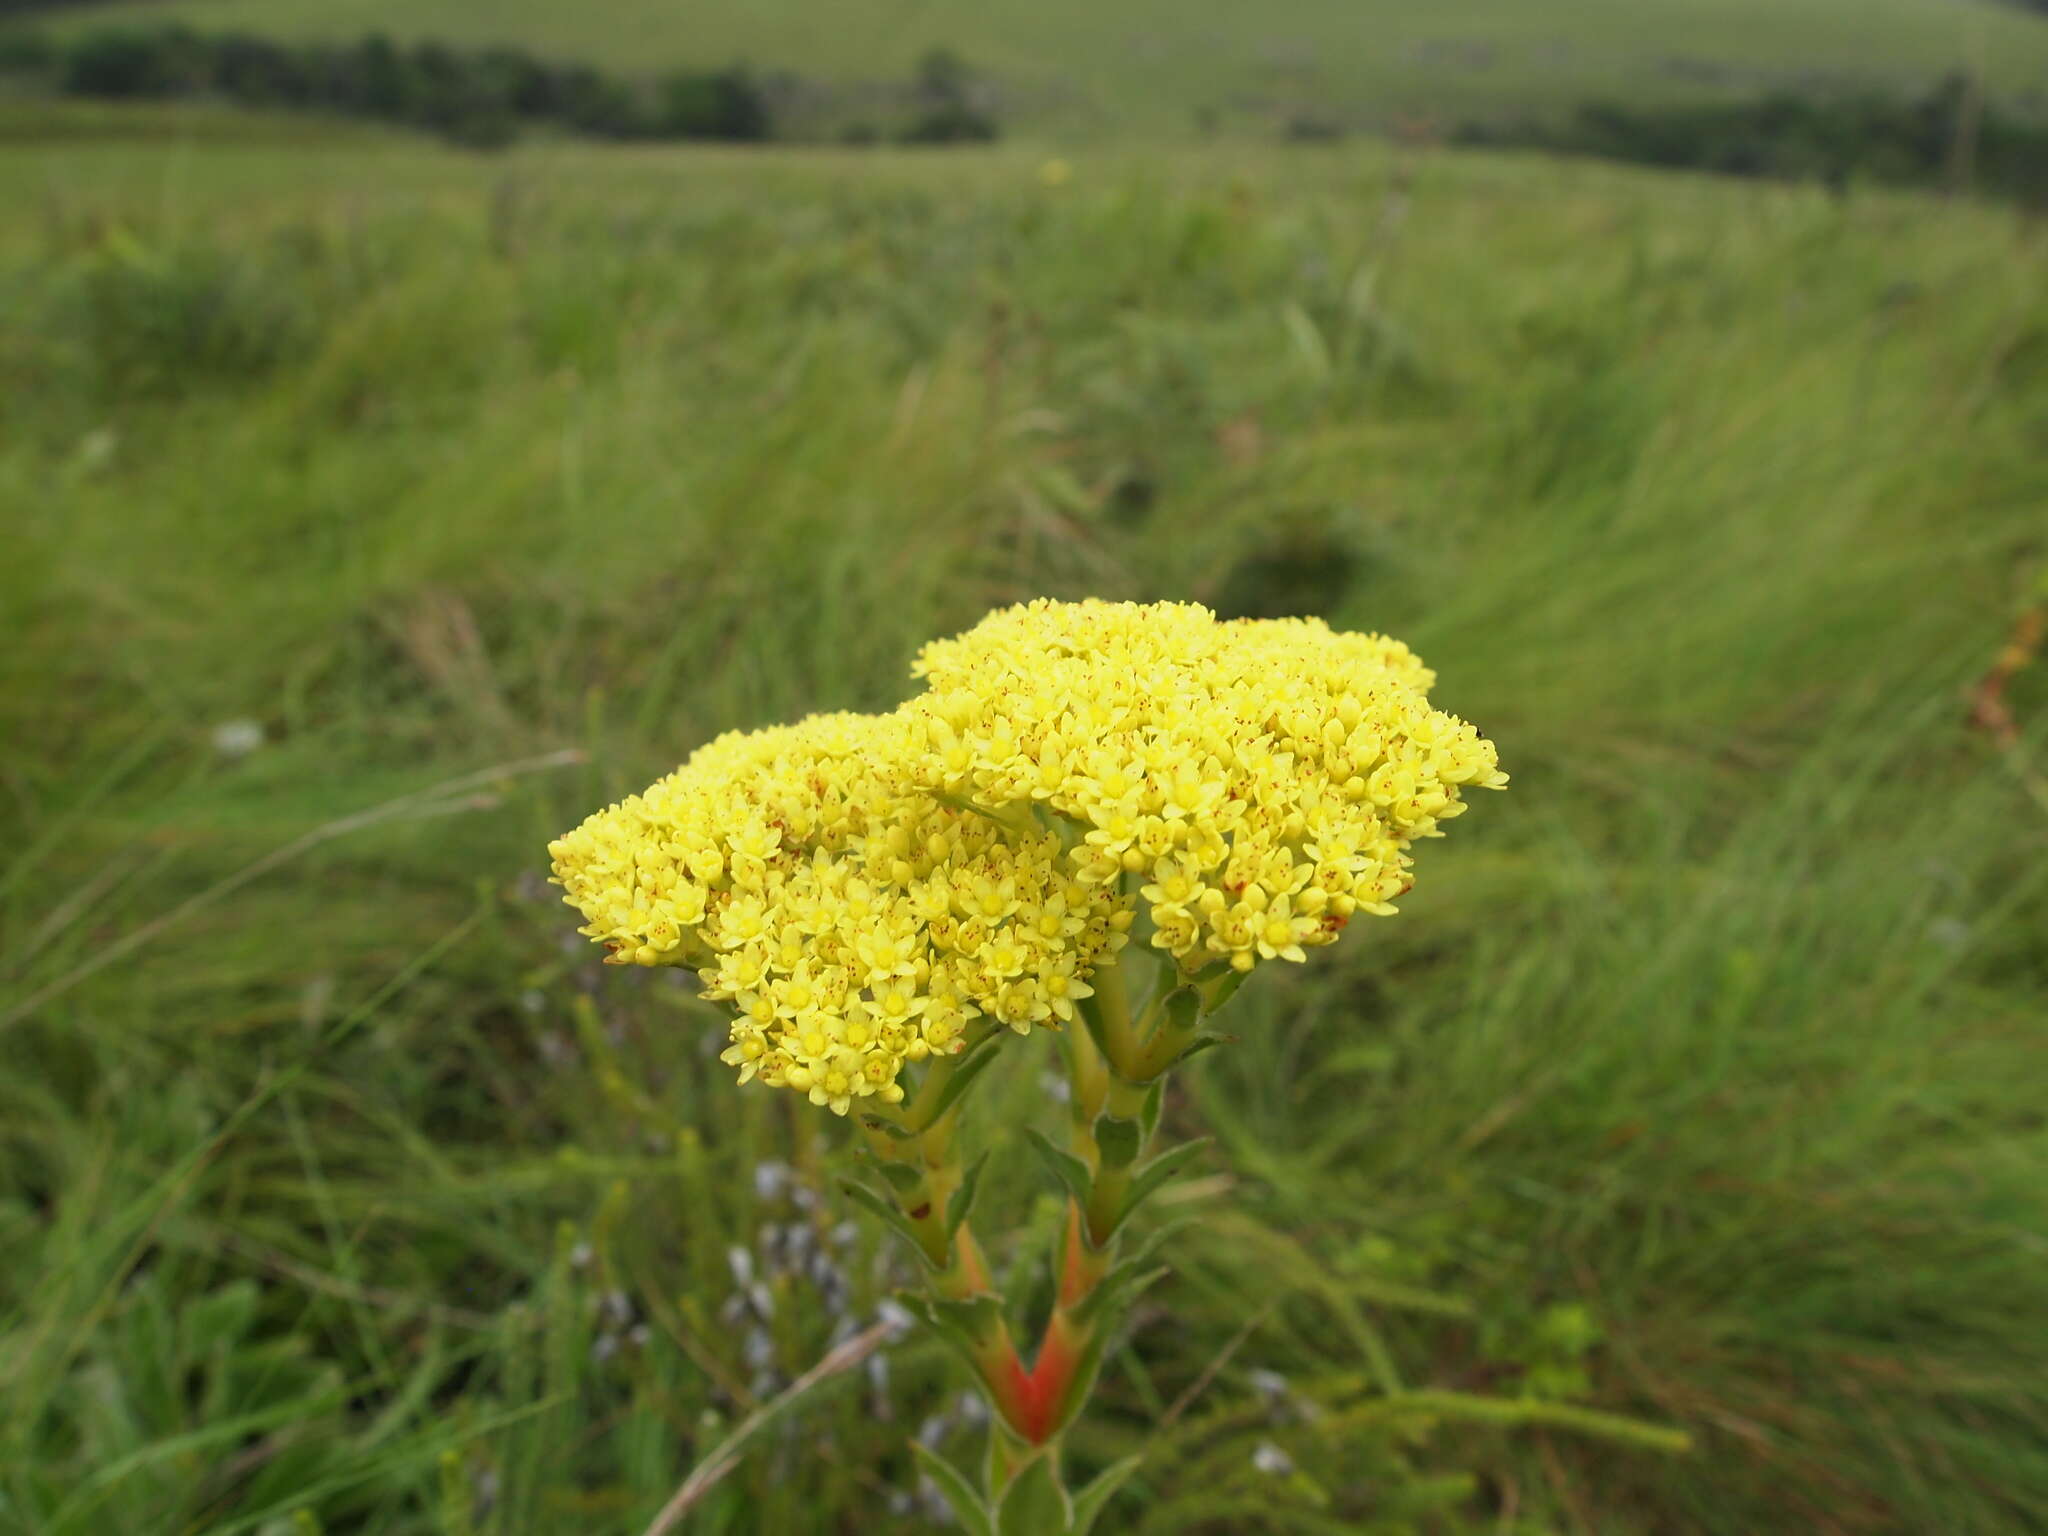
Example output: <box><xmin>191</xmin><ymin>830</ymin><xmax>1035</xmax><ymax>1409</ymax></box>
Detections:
<box><xmin>0</xmin><ymin>25</ymin><xmax>997</xmax><ymax>147</ymax></box>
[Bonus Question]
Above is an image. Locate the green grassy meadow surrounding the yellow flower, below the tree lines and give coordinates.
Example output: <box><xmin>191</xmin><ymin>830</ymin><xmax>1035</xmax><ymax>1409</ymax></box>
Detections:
<box><xmin>0</xmin><ymin>120</ymin><xmax>2048</xmax><ymax>1536</ymax></box>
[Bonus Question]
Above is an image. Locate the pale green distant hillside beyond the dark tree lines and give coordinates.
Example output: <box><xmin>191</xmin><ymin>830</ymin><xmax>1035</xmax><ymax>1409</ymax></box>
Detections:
<box><xmin>12</xmin><ymin>0</ymin><xmax>2048</xmax><ymax>139</ymax></box>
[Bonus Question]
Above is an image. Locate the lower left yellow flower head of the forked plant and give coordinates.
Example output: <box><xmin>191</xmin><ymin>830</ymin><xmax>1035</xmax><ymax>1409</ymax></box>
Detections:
<box><xmin>549</xmin><ymin>715</ymin><xmax>1130</xmax><ymax>1114</ymax></box>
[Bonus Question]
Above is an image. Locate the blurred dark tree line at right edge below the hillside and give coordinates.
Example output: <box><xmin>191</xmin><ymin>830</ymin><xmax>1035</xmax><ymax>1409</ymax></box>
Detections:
<box><xmin>1454</xmin><ymin>75</ymin><xmax>2048</xmax><ymax>207</ymax></box>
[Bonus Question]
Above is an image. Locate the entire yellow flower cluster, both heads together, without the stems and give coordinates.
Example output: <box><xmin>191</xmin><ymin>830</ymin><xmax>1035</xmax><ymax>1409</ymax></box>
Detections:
<box><xmin>549</xmin><ymin>602</ymin><xmax>1507</xmax><ymax>1114</ymax></box>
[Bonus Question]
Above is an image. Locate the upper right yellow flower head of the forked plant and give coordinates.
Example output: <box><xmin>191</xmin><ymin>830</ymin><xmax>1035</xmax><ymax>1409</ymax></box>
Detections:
<box><xmin>903</xmin><ymin>600</ymin><xmax>1507</xmax><ymax>973</ymax></box>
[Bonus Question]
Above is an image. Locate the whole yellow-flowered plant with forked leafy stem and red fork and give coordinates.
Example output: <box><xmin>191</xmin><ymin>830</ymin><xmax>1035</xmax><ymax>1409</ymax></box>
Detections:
<box><xmin>551</xmin><ymin>602</ymin><xmax>1507</xmax><ymax>1536</ymax></box>
